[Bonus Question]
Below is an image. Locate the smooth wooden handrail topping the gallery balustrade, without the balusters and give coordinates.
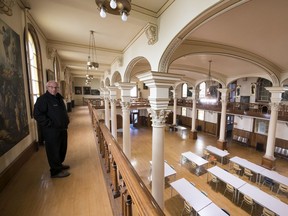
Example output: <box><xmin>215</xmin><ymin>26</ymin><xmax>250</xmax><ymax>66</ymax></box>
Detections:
<box><xmin>88</xmin><ymin>104</ymin><xmax>165</xmax><ymax>216</ymax></box>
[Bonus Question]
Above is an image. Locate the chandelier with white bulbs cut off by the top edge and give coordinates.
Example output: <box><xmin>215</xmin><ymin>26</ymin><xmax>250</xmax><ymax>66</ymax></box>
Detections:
<box><xmin>95</xmin><ymin>0</ymin><xmax>131</xmax><ymax>22</ymax></box>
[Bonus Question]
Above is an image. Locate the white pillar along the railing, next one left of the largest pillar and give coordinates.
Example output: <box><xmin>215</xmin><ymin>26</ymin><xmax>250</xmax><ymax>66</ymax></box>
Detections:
<box><xmin>115</xmin><ymin>82</ymin><xmax>135</xmax><ymax>160</ymax></box>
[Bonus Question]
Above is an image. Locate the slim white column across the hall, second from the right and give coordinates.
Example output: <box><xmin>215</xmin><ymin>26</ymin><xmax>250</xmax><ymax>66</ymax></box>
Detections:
<box><xmin>218</xmin><ymin>88</ymin><xmax>229</xmax><ymax>142</ymax></box>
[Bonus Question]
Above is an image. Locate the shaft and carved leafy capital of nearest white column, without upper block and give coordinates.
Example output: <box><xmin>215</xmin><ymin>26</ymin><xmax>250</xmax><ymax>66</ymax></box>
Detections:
<box><xmin>148</xmin><ymin>109</ymin><xmax>170</xmax><ymax>208</ymax></box>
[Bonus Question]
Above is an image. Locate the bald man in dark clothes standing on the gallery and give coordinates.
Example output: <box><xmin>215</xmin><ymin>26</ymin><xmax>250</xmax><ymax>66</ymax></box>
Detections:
<box><xmin>34</xmin><ymin>80</ymin><xmax>70</xmax><ymax>178</ymax></box>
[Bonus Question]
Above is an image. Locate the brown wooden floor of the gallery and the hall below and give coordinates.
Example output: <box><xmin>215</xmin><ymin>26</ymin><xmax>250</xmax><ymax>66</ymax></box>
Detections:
<box><xmin>0</xmin><ymin>106</ymin><xmax>288</xmax><ymax>216</ymax></box>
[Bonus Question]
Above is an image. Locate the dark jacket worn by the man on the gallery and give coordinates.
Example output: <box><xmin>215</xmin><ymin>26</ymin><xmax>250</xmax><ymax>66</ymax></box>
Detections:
<box><xmin>34</xmin><ymin>91</ymin><xmax>69</xmax><ymax>130</ymax></box>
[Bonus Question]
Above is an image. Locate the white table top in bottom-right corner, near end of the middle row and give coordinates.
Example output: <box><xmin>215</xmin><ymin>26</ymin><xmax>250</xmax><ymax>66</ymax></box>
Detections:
<box><xmin>238</xmin><ymin>184</ymin><xmax>288</xmax><ymax>216</ymax></box>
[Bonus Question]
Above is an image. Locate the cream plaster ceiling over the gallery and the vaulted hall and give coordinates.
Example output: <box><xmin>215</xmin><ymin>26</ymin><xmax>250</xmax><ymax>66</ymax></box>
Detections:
<box><xmin>25</xmin><ymin>0</ymin><xmax>288</xmax><ymax>85</ymax></box>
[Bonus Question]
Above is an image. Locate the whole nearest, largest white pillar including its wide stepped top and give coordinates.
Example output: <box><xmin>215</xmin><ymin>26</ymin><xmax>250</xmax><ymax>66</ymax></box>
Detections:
<box><xmin>137</xmin><ymin>72</ymin><xmax>180</xmax><ymax>209</ymax></box>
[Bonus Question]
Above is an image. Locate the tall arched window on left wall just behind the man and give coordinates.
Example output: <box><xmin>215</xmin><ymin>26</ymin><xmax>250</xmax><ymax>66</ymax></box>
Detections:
<box><xmin>25</xmin><ymin>24</ymin><xmax>43</xmax><ymax>116</ymax></box>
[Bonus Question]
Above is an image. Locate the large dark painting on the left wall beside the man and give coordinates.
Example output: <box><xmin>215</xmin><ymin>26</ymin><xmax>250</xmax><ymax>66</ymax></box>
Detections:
<box><xmin>0</xmin><ymin>19</ymin><xmax>29</xmax><ymax>157</ymax></box>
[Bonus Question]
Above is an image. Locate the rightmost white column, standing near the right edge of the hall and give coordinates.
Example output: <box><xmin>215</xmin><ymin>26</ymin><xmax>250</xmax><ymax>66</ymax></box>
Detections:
<box><xmin>264</xmin><ymin>87</ymin><xmax>285</xmax><ymax>160</ymax></box>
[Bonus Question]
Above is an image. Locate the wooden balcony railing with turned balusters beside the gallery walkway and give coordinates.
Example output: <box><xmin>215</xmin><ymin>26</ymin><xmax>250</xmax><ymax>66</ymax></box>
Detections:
<box><xmin>88</xmin><ymin>103</ymin><xmax>164</xmax><ymax>216</ymax></box>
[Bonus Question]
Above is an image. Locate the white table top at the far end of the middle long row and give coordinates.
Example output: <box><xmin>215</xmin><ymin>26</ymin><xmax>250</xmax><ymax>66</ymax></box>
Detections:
<box><xmin>207</xmin><ymin>166</ymin><xmax>247</xmax><ymax>189</ymax></box>
